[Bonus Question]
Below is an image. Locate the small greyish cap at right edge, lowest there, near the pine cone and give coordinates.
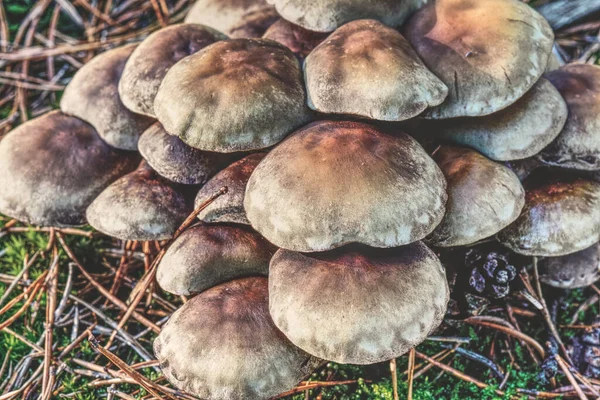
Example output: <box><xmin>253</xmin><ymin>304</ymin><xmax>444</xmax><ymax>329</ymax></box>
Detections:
<box><xmin>539</xmin><ymin>243</ymin><xmax>600</xmax><ymax>289</ymax></box>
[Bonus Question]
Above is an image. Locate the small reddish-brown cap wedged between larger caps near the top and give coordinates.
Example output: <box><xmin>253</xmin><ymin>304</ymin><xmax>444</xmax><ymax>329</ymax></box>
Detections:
<box><xmin>263</xmin><ymin>18</ymin><xmax>328</xmax><ymax>60</ymax></box>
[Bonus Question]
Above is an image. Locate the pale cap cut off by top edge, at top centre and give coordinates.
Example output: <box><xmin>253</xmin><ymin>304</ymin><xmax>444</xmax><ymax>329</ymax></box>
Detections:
<box><xmin>267</xmin><ymin>0</ymin><xmax>426</xmax><ymax>32</ymax></box>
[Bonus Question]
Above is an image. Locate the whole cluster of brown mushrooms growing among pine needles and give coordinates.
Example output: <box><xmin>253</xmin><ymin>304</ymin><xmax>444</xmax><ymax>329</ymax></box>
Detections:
<box><xmin>0</xmin><ymin>0</ymin><xmax>600</xmax><ymax>399</ymax></box>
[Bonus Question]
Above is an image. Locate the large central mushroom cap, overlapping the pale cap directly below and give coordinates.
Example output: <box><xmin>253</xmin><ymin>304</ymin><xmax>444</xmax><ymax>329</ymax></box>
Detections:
<box><xmin>244</xmin><ymin>121</ymin><xmax>447</xmax><ymax>251</ymax></box>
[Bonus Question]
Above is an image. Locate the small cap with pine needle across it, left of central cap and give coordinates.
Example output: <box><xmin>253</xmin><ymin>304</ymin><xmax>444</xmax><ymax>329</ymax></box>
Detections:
<box><xmin>194</xmin><ymin>153</ymin><xmax>266</xmax><ymax>225</ymax></box>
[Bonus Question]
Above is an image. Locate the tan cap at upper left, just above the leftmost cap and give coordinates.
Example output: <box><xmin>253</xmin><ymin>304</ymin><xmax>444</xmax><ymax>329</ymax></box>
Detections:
<box><xmin>60</xmin><ymin>44</ymin><xmax>154</xmax><ymax>150</ymax></box>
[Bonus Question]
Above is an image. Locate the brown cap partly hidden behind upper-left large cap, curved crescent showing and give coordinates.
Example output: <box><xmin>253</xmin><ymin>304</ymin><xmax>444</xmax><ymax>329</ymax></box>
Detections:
<box><xmin>119</xmin><ymin>24</ymin><xmax>227</xmax><ymax>117</ymax></box>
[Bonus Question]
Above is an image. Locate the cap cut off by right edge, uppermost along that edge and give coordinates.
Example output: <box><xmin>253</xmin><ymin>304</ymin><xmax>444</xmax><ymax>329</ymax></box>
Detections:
<box><xmin>539</xmin><ymin>64</ymin><xmax>600</xmax><ymax>170</ymax></box>
